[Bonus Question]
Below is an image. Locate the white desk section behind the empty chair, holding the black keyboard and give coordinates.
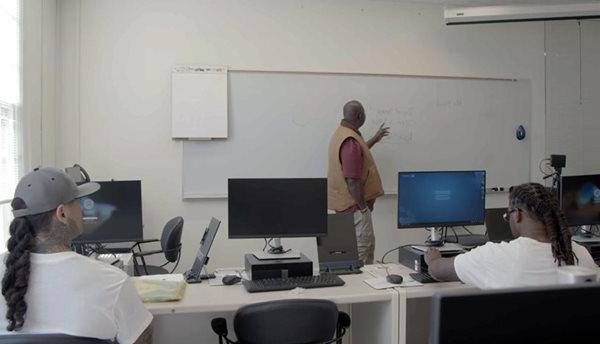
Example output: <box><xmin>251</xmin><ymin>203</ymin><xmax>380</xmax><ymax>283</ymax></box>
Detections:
<box><xmin>146</xmin><ymin>273</ymin><xmax>400</xmax><ymax>344</ymax></box>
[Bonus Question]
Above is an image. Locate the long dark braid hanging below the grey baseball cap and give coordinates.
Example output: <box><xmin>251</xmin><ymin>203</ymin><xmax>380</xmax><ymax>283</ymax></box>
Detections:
<box><xmin>2</xmin><ymin>198</ymin><xmax>54</xmax><ymax>331</ymax></box>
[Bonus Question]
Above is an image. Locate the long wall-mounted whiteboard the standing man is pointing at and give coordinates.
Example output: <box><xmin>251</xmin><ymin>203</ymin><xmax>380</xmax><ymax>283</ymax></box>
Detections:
<box><xmin>182</xmin><ymin>71</ymin><xmax>531</xmax><ymax>198</ymax></box>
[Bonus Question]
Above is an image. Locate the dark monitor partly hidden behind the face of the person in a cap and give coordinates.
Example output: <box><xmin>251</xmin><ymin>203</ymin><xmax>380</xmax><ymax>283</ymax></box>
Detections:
<box><xmin>74</xmin><ymin>180</ymin><xmax>144</xmax><ymax>243</ymax></box>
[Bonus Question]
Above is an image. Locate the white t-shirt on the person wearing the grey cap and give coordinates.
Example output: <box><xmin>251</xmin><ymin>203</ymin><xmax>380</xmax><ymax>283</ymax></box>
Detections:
<box><xmin>0</xmin><ymin>252</ymin><xmax>152</xmax><ymax>344</ymax></box>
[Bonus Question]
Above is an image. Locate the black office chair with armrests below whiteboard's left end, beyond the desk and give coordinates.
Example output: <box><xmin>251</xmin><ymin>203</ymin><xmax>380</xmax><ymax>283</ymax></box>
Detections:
<box><xmin>132</xmin><ymin>216</ymin><xmax>183</xmax><ymax>276</ymax></box>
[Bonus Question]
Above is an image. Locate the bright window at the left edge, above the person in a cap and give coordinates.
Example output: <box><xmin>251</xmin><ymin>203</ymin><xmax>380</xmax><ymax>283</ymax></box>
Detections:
<box><xmin>0</xmin><ymin>0</ymin><xmax>23</xmax><ymax>251</ymax></box>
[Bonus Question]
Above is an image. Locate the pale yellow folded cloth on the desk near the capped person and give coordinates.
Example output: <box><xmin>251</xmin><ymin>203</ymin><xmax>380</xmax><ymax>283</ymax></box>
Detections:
<box><xmin>133</xmin><ymin>275</ymin><xmax>187</xmax><ymax>302</ymax></box>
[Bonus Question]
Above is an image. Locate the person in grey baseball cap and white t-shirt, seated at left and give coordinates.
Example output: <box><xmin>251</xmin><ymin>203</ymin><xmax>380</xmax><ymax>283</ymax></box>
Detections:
<box><xmin>0</xmin><ymin>168</ymin><xmax>152</xmax><ymax>344</ymax></box>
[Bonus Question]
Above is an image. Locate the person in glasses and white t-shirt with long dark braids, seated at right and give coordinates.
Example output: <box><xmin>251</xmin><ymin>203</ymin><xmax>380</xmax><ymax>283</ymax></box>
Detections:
<box><xmin>425</xmin><ymin>183</ymin><xmax>598</xmax><ymax>289</ymax></box>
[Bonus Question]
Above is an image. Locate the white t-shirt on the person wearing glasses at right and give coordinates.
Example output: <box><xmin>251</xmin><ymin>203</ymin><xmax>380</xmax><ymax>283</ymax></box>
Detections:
<box><xmin>454</xmin><ymin>237</ymin><xmax>598</xmax><ymax>289</ymax></box>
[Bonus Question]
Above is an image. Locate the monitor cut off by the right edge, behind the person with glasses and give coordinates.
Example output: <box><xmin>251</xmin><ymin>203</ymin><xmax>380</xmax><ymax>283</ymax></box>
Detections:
<box><xmin>560</xmin><ymin>174</ymin><xmax>600</xmax><ymax>226</ymax></box>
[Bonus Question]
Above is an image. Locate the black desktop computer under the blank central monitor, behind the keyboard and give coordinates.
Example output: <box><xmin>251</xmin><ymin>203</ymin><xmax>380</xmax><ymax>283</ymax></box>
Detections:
<box><xmin>244</xmin><ymin>253</ymin><xmax>313</xmax><ymax>280</ymax></box>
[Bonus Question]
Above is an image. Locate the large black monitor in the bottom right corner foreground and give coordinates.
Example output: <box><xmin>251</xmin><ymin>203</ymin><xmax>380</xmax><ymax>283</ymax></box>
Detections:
<box><xmin>429</xmin><ymin>283</ymin><xmax>600</xmax><ymax>344</ymax></box>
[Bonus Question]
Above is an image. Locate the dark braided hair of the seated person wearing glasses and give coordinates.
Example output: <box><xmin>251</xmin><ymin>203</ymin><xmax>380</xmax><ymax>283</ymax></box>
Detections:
<box><xmin>509</xmin><ymin>183</ymin><xmax>577</xmax><ymax>265</ymax></box>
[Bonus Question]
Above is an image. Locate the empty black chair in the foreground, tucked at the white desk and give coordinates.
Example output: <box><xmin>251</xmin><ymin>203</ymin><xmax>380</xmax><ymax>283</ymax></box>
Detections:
<box><xmin>211</xmin><ymin>299</ymin><xmax>350</xmax><ymax>344</ymax></box>
